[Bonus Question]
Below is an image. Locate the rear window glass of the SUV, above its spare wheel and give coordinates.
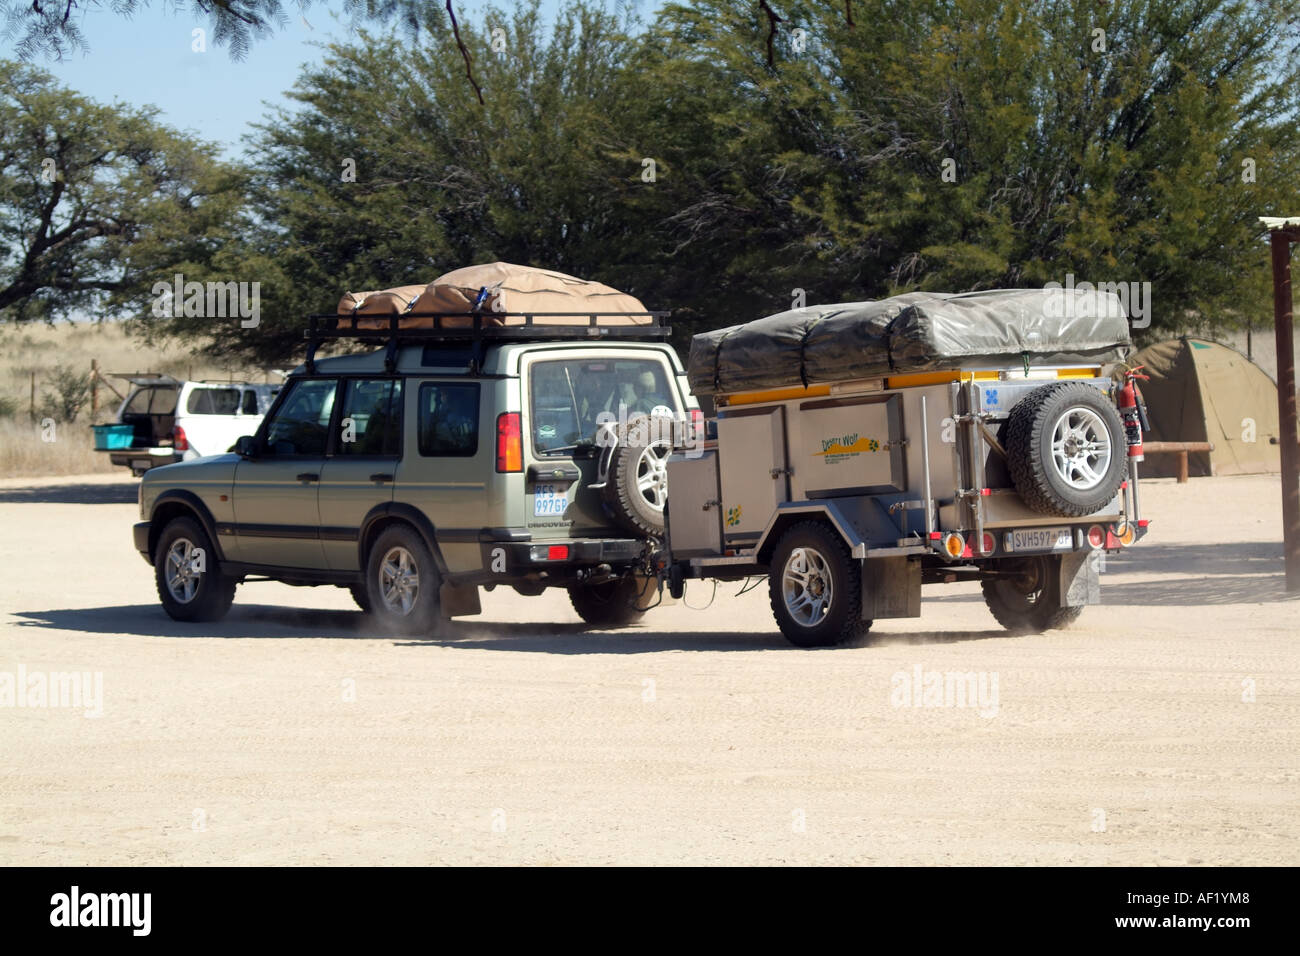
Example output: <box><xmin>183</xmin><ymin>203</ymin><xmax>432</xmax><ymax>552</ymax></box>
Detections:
<box><xmin>532</xmin><ymin>359</ymin><xmax>677</xmax><ymax>455</ymax></box>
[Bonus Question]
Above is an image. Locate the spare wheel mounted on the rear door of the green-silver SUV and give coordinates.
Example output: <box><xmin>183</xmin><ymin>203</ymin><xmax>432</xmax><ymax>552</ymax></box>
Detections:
<box><xmin>605</xmin><ymin>415</ymin><xmax>672</xmax><ymax>538</ymax></box>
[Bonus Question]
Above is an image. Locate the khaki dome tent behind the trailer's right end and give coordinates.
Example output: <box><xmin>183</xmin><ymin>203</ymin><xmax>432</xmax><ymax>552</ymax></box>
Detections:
<box><xmin>1130</xmin><ymin>337</ymin><xmax>1281</xmax><ymax>477</ymax></box>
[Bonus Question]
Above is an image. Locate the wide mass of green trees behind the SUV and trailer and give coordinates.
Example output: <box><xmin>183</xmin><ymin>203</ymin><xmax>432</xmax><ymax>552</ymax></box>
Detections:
<box><xmin>58</xmin><ymin>0</ymin><xmax>1300</xmax><ymax>363</ymax></box>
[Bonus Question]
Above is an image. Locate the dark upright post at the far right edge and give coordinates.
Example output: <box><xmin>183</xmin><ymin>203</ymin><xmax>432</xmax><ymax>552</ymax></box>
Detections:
<box><xmin>1269</xmin><ymin>229</ymin><xmax>1300</xmax><ymax>593</ymax></box>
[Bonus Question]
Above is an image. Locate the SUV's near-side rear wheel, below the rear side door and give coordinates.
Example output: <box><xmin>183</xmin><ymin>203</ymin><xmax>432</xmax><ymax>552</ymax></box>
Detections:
<box><xmin>365</xmin><ymin>524</ymin><xmax>442</xmax><ymax>635</ymax></box>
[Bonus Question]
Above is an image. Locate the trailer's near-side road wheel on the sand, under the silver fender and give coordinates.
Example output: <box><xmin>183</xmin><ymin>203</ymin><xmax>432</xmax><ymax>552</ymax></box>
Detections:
<box><xmin>767</xmin><ymin>522</ymin><xmax>871</xmax><ymax>648</ymax></box>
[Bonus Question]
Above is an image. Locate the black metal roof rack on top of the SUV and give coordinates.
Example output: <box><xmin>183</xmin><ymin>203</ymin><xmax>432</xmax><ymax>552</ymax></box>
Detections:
<box><xmin>304</xmin><ymin>312</ymin><xmax>672</xmax><ymax>373</ymax></box>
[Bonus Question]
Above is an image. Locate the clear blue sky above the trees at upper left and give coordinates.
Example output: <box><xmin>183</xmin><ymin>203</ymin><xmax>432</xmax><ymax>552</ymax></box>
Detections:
<box><xmin>27</xmin><ymin>0</ymin><xmax>660</xmax><ymax>159</ymax></box>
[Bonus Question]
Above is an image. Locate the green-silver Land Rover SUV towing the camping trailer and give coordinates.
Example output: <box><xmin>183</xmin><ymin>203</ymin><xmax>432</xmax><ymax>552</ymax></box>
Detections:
<box><xmin>134</xmin><ymin>316</ymin><xmax>703</xmax><ymax>633</ymax></box>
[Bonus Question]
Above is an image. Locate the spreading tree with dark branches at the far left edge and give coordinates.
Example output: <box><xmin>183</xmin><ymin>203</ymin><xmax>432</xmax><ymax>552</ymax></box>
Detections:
<box><xmin>0</xmin><ymin>64</ymin><xmax>241</xmax><ymax>321</ymax></box>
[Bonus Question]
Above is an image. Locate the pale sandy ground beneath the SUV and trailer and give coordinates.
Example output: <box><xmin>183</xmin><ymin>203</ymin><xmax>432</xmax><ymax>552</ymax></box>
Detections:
<box><xmin>0</xmin><ymin>476</ymin><xmax>1300</xmax><ymax>865</ymax></box>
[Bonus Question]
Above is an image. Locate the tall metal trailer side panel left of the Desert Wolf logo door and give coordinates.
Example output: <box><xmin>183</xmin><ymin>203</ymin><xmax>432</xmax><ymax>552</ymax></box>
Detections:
<box><xmin>718</xmin><ymin>406</ymin><xmax>790</xmax><ymax>545</ymax></box>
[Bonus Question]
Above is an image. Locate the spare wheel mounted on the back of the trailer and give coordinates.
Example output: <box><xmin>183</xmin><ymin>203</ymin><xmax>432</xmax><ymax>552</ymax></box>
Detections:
<box><xmin>1002</xmin><ymin>381</ymin><xmax>1128</xmax><ymax>518</ymax></box>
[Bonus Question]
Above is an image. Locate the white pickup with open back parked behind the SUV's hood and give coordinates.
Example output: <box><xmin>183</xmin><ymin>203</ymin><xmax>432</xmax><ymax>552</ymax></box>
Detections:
<box><xmin>98</xmin><ymin>373</ymin><xmax>280</xmax><ymax>476</ymax></box>
